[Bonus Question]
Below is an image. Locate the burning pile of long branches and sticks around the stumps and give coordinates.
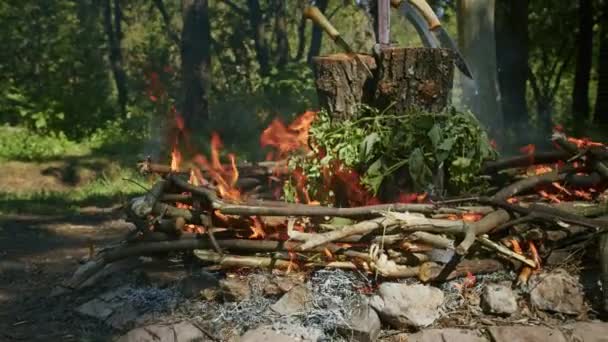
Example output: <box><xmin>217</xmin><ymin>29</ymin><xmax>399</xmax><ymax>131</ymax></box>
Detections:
<box><xmin>58</xmin><ymin>122</ymin><xmax>608</xmax><ymax>312</ymax></box>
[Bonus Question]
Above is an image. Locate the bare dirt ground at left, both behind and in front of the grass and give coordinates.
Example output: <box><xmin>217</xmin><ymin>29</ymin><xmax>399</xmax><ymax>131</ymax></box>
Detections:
<box><xmin>0</xmin><ymin>160</ymin><xmax>133</xmax><ymax>341</ymax></box>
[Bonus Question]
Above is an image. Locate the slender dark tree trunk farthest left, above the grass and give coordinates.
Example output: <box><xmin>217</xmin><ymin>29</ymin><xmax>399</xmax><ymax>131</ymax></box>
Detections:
<box><xmin>103</xmin><ymin>0</ymin><xmax>128</xmax><ymax>116</ymax></box>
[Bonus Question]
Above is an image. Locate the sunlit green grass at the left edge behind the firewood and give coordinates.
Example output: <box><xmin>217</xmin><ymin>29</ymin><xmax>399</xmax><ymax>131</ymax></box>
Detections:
<box><xmin>0</xmin><ymin>123</ymin><xmax>150</xmax><ymax>215</ymax></box>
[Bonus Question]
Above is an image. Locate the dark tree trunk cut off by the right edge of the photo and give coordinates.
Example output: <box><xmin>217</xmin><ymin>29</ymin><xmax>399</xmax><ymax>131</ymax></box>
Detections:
<box><xmin>594</xmin><ymin>1</ymin><xmax>608</xmax><ymax>124</ymax></box>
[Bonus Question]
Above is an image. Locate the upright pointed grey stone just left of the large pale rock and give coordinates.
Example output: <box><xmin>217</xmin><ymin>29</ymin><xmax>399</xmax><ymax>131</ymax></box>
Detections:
<box><xmin>338</xmin><ymin>297</ymin><xmax>382</xmax><ymax>342</ymax></box>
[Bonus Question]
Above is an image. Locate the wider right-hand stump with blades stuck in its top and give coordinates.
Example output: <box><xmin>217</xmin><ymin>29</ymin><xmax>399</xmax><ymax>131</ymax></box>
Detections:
<box><xmin>373</xmin><ymin>47</ymin><xmax>454</xmax><ymax>113</ymax></box>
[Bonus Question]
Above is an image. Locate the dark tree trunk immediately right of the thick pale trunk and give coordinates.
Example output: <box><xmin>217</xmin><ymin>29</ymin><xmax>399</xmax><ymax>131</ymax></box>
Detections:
<box><xmin>496</xmin><ymin>0</ymin><xmax>528</xmax><ymax>132</ymax></box>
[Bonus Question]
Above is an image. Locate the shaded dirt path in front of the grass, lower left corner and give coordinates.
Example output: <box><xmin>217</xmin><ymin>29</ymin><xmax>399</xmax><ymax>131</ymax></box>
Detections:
<box><xmin>0</xmin><ymin>215</ymin><xmax>128</xmax><ymax>341</ymax></box>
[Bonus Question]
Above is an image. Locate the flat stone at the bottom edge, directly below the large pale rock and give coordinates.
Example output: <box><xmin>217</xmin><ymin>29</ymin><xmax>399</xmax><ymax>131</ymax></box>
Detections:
<box><xmin>387</xmin><ymin>328</ymin><xmax>490</xmax><ymax>342</ymax></box>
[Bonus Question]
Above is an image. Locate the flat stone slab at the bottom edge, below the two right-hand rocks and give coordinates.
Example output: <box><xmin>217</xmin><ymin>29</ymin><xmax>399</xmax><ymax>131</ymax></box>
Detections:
<box><xmin>488</xmin><ymin>326</ymin><xmax>566</xmax><ymax>342</ymax></box>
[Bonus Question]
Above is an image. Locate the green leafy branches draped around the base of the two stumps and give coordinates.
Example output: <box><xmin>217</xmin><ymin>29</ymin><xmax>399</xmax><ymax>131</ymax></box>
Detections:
<box><xmin>286</xmin><ymin>105</ymin><xmax>496</xmax><ymax>198</ymax></box>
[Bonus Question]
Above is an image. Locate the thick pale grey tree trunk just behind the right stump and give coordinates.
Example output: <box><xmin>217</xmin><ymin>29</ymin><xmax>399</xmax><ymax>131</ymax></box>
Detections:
<box><xmin>457</xmin><ymin>0</ymin><xmax>503</xmax><ymax>143</ymax></box>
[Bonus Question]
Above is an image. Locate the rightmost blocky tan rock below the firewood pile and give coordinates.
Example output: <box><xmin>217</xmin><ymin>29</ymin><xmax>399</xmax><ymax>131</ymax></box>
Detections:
<box><xmin>530</xmin><ymin>269</ymin><xmax>585</xmax><ymax>315</ymax></box>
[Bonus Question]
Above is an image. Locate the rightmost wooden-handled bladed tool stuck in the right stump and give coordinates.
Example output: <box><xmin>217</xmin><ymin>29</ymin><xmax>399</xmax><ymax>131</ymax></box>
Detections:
<box><xmin>390</xmin><ymin>0</ymin><xmax>473</xmax><ymax>79</ymax></box>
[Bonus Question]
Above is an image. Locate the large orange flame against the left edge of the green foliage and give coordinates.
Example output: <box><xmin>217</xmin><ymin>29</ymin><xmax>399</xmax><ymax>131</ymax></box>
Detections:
<box><xmin>260</xmin><ymin>111</ymin><xmax>317</xmax><ymax>157</ymax></box>
